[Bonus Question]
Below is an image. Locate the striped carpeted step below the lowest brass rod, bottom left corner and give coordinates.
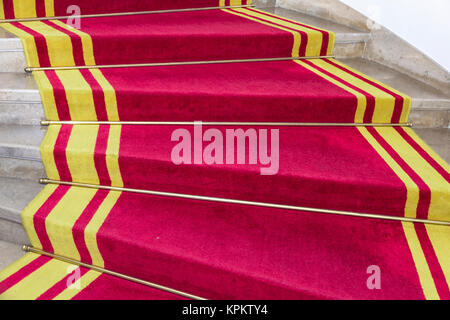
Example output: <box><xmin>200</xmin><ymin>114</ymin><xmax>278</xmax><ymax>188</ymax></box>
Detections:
<box><xmin>0</xmin><ymin>252</ymin><xmax>187</xmax><ymax>300</ymax></box>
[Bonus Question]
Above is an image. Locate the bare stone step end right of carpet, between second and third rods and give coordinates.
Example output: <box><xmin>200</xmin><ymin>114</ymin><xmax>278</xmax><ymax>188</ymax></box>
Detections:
<box><xmin>341</xmin><ymin>58</ymin><xmax>450</xmax><ymax>128</ymax></box>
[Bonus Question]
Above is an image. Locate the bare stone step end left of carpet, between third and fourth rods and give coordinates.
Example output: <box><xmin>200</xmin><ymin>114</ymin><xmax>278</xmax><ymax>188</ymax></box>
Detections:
<box><xmin>0</xmin><ymin>125</ymin><xmax>46</xmax><ymax>181</ymax></box>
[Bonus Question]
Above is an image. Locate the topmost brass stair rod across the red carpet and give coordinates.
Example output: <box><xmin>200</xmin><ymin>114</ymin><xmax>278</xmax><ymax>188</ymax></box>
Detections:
<box><xmin>0</xmin><ymin>4</ymin><xmax>255</xmax><ymax>23</ymax></box>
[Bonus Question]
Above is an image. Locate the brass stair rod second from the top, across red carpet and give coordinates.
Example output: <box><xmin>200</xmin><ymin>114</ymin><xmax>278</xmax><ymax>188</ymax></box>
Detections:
<box><xmin>25</xmin><ymin>56</ymin><xmax>335</xmax><ymax>72</ymax></box>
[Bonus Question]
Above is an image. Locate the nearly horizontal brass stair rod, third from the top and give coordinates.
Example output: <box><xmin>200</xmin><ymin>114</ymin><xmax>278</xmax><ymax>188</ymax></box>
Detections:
<box><xmin>41</xmin><ymin>120</ymin><xmax>412</xmax><ymax>127</ymax></box>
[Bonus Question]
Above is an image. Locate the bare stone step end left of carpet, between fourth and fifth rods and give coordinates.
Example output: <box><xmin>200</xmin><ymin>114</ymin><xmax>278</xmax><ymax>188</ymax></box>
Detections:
<box><xmin>0</xmin><ymin>176</ymin><xmax>43</xmax><ymax>244</ymax></box>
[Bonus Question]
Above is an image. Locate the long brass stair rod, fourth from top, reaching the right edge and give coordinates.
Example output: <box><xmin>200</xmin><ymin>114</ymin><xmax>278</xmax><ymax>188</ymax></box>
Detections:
<box><xmin>39</xmin><ymin>178</ymin><xmax>450</xmax><ymax>226</ymax></box>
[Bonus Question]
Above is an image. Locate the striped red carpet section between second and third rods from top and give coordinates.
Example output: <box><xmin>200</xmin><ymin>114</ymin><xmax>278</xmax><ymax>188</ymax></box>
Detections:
<box><xmin>37</xmin><ymin>60</ymin><xmax>411</xmax><ymax>123</ymax></box>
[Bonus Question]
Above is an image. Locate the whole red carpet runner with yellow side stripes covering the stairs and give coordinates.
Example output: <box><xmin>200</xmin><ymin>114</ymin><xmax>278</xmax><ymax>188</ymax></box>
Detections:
<box><xmin>0</xmin><ymin>0</ymin><xmax>450</xmax><ymax>299</ymax></box>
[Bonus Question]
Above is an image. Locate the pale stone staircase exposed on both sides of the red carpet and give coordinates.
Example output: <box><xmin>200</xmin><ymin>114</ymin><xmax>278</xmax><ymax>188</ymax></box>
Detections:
<box><xmin>0</xmin><ymin>4</ymin><xmax>450</xmax><ymax>278</ymax></box>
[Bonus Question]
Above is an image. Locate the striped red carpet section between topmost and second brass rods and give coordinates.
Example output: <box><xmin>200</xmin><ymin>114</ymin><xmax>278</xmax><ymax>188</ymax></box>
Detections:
<box><xmin>9</xmin><ymin>8</ymin><xmax>334</xmax><ymax>67</ymax></box>
